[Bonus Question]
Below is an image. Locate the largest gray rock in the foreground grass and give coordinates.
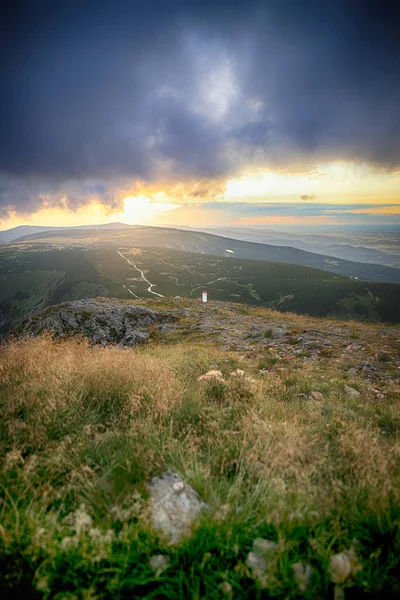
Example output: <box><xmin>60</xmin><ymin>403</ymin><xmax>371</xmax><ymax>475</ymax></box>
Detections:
<box><xmin>148</xmin><ymin>471</ymin><xmax>208</xmax><ymax>543</ymax></box>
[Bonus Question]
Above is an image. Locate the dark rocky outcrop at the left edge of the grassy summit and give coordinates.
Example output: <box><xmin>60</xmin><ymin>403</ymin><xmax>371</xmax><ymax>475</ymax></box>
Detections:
<box><xmin>16</xmin><ymin>300</ymin><xmax>177</xmax><ymax>347</ymax></box>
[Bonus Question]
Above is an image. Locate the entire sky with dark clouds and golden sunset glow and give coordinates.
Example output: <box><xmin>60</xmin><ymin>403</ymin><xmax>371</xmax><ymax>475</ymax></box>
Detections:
<box><xmin>0</xmin><ymin>0</ymin><xmax>400</xmax><ymax>229</ymax></box>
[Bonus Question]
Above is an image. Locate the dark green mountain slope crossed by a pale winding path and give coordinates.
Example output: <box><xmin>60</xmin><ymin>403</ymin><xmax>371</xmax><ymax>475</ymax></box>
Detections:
<box><xmin>0</xmin><ymin>244</ymin><xmax>400</xmax><ymax>334</ymax></box>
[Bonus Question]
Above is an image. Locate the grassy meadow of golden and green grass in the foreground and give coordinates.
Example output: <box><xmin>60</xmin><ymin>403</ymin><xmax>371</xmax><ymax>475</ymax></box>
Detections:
<box><xmin>0</xmin><ymin>309</ymin><xmax>400</xmax><ymax>600</ymax></box>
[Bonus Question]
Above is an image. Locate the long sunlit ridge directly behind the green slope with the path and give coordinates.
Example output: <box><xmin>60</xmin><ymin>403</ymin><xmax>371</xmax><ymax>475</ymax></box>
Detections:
<box><xmin>18</xmin><ymin>226</ymin><xmax>400</xmax><ymax>283</ymax></box>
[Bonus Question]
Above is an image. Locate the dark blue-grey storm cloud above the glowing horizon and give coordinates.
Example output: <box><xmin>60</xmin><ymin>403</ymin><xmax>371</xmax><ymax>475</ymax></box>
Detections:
<box><xmin>0</xmin><ymin>0</ymin><xmax>400</xmax><ymax>216</ymax></box>
